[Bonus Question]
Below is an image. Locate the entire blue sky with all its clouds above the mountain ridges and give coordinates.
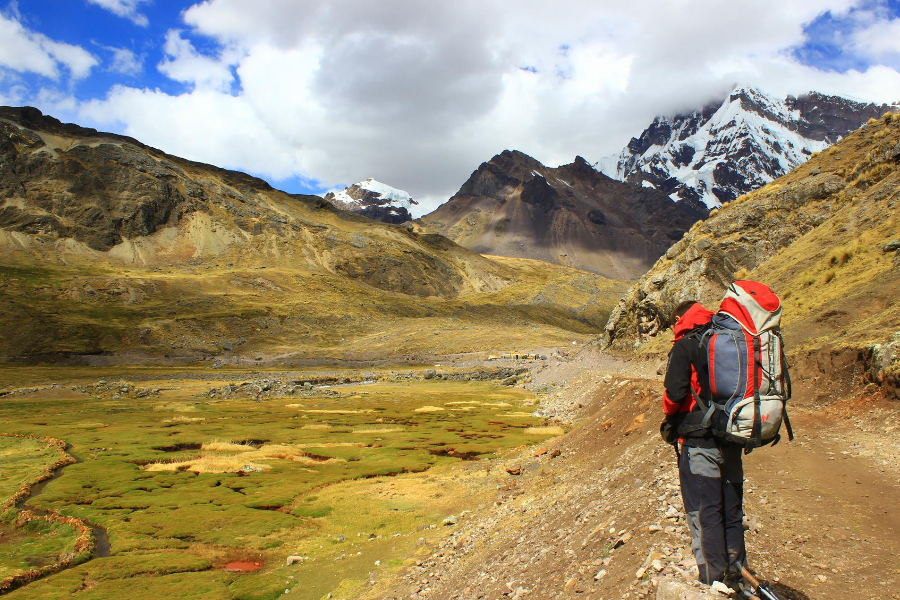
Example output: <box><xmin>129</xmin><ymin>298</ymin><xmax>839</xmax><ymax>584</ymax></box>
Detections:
<box><xmin>0</xmin><ymin>0</ymin><xmax>900</xmax><ymax>209</ymax></box>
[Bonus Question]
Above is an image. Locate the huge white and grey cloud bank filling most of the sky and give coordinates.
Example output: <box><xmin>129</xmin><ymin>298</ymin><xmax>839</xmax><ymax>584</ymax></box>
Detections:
<box><xmin>75</xmin><ymin>0</ymin><xmax>900</xmax><ymax>216</ymax></box>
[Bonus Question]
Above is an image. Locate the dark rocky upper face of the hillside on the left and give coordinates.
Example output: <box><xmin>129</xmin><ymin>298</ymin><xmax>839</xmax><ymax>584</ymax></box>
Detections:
<box><xmin>0</xmin><ymin>107</ymin><xmax>322</xmax><ymax>251</ymax></box>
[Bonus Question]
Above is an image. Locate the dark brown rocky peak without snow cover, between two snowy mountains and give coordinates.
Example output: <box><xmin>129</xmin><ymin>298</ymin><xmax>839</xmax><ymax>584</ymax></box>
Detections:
<box><xmin>420</xmin><ymin>150</ymin><xmax>706</xmax><ymax>279</ymax></box>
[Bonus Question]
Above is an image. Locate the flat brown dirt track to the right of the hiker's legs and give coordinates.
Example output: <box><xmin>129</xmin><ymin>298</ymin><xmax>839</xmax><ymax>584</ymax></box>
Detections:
<box><xmin>745</xmin><ymin>413</ymin><xmax>900</xmax><ymax>599</ymax></box>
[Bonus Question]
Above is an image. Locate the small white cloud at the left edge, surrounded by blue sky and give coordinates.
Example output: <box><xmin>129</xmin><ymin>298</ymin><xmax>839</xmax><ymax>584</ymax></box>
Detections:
<box><xmin>0</xmin><ymin>13</ymin><xmax>97</xmax><ymax>80</ymax></box>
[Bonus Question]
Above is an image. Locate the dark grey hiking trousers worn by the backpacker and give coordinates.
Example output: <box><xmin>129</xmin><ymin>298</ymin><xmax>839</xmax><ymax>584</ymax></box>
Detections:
<box><xmin>678</xmin><ymin>446</ymin><xmax>747</xmax><ymax>584</ymax></box>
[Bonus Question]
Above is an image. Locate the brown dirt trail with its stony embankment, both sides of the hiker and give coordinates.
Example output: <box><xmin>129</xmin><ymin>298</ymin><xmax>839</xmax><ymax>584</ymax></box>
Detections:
<box><xmin>360</xmin><ymin>352</ymin><xmax>900</xmax><ymax>600</ymax></box>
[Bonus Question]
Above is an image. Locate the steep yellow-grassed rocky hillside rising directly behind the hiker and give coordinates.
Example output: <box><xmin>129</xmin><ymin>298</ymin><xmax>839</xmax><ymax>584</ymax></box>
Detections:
<box><xmin>606</xmin><ymin>114</ymin><xmax>900</xmax><ymax>394</ymax></box>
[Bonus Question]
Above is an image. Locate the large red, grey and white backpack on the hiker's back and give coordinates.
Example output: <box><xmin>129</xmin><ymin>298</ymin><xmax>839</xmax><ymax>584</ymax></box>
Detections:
<box><xmin>694</xmin><ymin>281</ymin><xmax>794</xmax><ymax>451</ymax></box>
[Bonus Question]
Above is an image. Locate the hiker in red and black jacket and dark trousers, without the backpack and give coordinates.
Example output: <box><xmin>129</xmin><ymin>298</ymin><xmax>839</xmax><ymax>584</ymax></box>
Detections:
<box><xmin>662</xmin><ymin>300</ymin><xmax>747</xmax><ymax>585</ymax></box>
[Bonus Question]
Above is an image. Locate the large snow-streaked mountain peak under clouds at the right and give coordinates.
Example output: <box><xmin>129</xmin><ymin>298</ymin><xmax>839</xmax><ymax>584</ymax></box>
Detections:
<box><xmin>601</xmin><ymin>86</ymin><xmax>889</xmax><ymax>208</ymax></box>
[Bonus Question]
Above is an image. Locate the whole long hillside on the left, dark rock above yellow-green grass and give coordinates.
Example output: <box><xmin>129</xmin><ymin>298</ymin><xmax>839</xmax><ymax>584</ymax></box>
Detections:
<box><xmin>0</xmin><ymin>108</ymin><xmax>621</xmax><ymax>362</ymax></box>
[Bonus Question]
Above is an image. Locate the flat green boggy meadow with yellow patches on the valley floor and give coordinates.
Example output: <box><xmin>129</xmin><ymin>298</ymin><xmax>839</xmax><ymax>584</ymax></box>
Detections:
<box><xmin>0</xmin><ymin>367</ymin><xmax>558</xmax><ymax>599</ymax></box>
